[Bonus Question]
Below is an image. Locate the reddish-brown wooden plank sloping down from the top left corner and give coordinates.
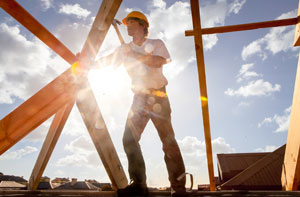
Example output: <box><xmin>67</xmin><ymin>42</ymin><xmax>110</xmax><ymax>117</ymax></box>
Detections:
<box><xmin>0</xmin><ymin>0</ymin><xmax>76</xmax><ymax>64</ymax></box>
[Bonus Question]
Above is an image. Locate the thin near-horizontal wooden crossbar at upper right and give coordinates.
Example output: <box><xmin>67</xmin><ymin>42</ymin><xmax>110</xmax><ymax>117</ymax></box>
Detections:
<box><xmin>185</xmin><ymin>18</ymin><xmax>297</xmax><ymax>36</ymax></box>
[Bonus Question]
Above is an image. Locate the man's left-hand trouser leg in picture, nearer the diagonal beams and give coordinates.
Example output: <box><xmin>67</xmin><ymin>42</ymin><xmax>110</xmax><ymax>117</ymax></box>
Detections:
<box><xmin>123</xmin><ymin>95</ymin><xmax>149</xmax><ymax>185</ymax></box>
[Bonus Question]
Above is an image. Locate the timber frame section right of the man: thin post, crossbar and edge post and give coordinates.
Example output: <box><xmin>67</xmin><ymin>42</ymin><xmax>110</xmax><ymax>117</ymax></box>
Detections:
<box><xmin>185</xmin><ymin>0</ymin><xmax>300</xmax><ymax>191</ymax></box>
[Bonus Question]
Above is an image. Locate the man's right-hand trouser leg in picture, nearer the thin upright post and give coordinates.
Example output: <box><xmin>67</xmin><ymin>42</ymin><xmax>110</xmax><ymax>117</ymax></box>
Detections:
<box><xmin>150</xmin><ymin>92</ymin><xmax>185</xmax><ymax>191</ymax></box>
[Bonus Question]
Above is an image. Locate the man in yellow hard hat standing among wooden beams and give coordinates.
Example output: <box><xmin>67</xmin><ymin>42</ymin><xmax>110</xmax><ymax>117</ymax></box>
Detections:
<box><xmin>76</xmin><ymin>11</ymin><xmax>185</xmax><ymax>196</ymax></box>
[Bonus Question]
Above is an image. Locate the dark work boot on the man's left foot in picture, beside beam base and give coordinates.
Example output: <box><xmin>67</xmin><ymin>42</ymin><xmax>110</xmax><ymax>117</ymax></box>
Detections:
<box><xmin>118</xmin><ymin>182</ymin><xmax>148</xmax><ymax>196</ymax></box>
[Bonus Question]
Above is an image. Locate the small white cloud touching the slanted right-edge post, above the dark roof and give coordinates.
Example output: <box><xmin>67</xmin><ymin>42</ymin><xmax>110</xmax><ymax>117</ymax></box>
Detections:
<box><xmin>258</xmin><ymin>106</ymin><xmax>292</xmax><ymax>133</ymax></box>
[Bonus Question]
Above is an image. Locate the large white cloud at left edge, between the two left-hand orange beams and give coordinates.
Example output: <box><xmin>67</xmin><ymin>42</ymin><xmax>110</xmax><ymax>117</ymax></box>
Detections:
<box><xmin>0</xmin><ymin>23</ymin><xmax>66</xmax><ymax>104</ymax></box>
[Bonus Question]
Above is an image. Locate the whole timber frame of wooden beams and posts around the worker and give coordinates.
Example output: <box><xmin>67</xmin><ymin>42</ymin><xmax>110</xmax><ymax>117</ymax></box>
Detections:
<box><xmin>0</xmin><ymin>0</ymin><xmax>300</xmax><ymax>191</ymax></box>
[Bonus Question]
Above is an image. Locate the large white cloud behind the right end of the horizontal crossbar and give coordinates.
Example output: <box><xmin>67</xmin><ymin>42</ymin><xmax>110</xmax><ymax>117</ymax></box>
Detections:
<box><xmin>241</xmin><ymin>10</ymin><xmax>297</xmax><ymax>60</ymax></box>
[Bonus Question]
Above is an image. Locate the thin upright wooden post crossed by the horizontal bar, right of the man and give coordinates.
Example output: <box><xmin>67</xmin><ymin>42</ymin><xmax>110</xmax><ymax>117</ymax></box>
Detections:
<box><xmin>191</xmin><ymin>0</ymin><xmax>216</xmax><ymax>191</ymax></box>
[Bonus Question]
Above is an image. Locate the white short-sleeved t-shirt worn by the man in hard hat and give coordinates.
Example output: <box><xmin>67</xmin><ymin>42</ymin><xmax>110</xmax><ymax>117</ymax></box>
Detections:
<box><xmin>115</xmin><ymin>39</ymin><xmax>171</xmax><ymax>93</ymax></box>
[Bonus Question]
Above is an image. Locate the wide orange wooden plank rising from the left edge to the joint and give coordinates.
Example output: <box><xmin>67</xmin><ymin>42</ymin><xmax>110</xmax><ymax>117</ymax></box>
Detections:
<box><xmin>0</xmin><ymin>69</ymin><xmax>76</xmax><ymax>155</ymax></box>
